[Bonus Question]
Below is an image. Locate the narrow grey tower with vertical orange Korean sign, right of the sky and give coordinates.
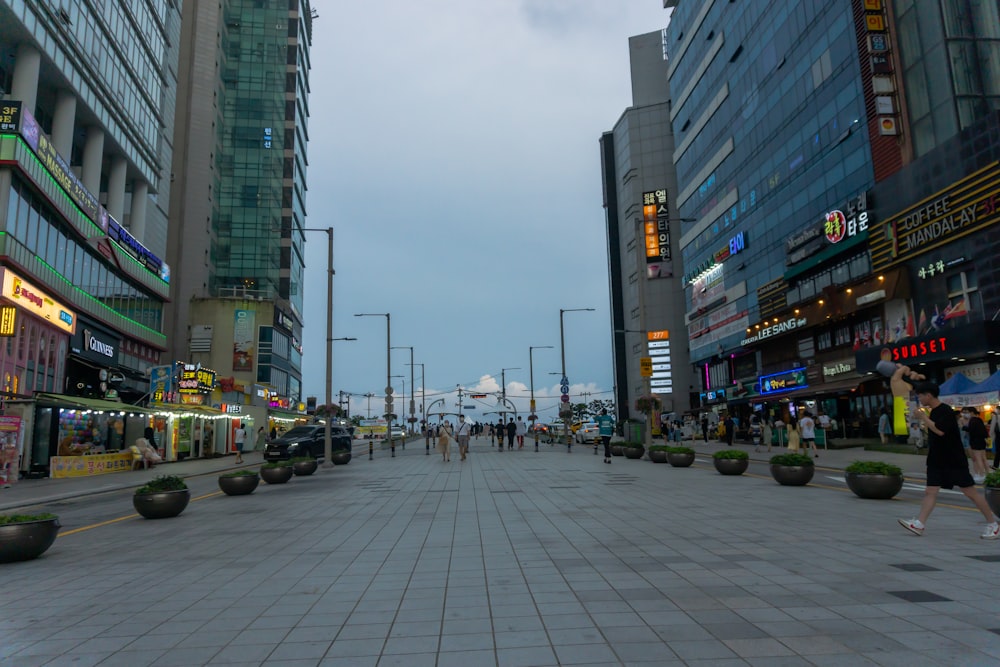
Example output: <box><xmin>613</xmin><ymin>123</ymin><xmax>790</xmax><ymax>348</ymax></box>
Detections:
<box><xmin>600</xmin><ymin>31</ymin><xmax>691</xmax><ymax>428</ymax></box>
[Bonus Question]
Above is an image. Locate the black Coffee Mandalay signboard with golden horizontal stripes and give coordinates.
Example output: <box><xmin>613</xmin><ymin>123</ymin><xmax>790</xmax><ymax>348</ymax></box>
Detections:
<box><xmin>870</xmin><ymin>162</ymin><xmax>1000</xmax><ymax>271</ymax></box>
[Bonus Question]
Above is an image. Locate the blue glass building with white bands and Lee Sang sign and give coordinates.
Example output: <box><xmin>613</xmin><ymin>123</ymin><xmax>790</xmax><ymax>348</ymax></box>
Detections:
<box><xmin>665</xmin><ymin>0</ymin><xmax>874</xmax><ymax>426</ymax></box>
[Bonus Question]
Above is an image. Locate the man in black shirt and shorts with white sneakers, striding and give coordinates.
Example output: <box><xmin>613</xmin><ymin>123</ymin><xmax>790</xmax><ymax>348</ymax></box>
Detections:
<box><xmin>899</xmin><ymin>378</ymin><xmax>1000</xmax><ymax>540</ymax></box>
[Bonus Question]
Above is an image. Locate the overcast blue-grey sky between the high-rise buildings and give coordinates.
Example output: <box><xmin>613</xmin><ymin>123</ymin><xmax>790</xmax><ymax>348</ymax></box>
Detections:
<box><xmin>303</xmin><ymin>0</ymin><xmax>669</xmax><ymax>420</ymax></box>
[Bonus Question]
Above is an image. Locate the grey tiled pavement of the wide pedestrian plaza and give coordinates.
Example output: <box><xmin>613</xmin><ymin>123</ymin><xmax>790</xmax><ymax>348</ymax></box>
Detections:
<box><xmin>0</xmin><ymin>439</ymin><xmax>1000</xmax><ymax>667</ymax></box>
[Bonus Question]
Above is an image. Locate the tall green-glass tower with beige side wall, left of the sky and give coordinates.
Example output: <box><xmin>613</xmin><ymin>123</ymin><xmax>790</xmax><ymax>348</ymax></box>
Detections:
<box><xmin>168</xmin><ymin>0</ymin><xmax>314</xmax><ymax>427</ymax></box>
